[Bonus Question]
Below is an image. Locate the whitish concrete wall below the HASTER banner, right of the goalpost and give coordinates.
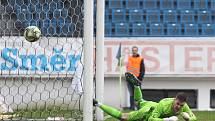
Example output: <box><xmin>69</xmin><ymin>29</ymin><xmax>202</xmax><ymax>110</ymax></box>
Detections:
<box><xmin>104</xmin><ymin>77</ymin><xmax>215</xmax><ymax>110</ymax></box>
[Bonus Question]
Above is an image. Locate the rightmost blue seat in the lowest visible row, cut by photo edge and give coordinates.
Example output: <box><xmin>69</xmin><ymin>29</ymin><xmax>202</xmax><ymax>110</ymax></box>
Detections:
<box><xmin>201</xmin><ymin>24</ymin><xmax>215</xmax><ymax>36</ymax></box>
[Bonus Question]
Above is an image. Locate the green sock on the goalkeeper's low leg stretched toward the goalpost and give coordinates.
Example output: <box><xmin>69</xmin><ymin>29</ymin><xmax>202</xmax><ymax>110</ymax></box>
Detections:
<box><xmin>99</xmin><ymin>104</ymin><xmax>122</xmax><ymax>119</ymax></box>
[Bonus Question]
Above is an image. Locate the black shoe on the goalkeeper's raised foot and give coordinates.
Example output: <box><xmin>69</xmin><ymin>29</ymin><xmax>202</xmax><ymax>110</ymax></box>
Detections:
<box><xmin>125</xmin><ymin>72</ymin><xmax>141</xmax><ymax>86</ymax></box>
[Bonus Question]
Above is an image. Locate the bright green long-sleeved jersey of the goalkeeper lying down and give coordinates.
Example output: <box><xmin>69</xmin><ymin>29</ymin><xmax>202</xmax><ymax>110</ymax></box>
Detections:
<box><xmin>148</xmin><ymin>98</ymin><xmax>196</xmax><ymax>121</ymax></box>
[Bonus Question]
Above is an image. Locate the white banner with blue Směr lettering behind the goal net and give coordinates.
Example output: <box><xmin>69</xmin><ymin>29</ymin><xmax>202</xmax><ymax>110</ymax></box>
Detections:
<box><xmin>0</xmin><ymin>37</ymin><xmax>83</xmax><ymax>76</ymax></box>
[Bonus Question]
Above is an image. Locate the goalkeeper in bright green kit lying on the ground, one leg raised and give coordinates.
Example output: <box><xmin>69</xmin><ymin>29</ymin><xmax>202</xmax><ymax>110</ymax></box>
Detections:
<box><xmin>93</xmin><ymin>72</ymin><xmax>196</xmax><ymax>121</ymax></box>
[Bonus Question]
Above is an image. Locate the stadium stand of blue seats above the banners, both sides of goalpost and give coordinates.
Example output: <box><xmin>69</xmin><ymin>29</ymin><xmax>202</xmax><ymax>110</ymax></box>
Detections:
<box><xmin>0</xmin><ymin>0</ymin><xmax>215</xmax><ymax>37</ymax></box>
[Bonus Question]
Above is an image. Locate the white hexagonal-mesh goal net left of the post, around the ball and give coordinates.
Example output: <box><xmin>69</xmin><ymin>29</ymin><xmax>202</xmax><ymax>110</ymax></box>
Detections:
<box><xmin>0</xmin><ymin>0</ymin><xmax>83</xmax><ymax>120</ymax></box>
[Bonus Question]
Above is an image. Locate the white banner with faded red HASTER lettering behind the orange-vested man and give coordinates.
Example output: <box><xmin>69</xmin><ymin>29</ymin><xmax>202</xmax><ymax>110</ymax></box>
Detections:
<box><xmin>105</xmin><ymin>37</ymin><xmax>215</xmax><ymax>76</ymax></box>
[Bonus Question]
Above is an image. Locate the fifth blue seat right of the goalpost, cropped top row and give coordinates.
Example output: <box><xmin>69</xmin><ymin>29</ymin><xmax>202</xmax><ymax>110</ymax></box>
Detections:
<box><xmin>177</xmin><ymin>0</ymin><xmax>192</xmax><ymax>9</ymax></box>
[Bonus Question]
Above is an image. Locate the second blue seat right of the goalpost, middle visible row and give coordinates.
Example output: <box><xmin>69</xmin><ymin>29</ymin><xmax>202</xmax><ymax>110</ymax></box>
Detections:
<box><xmin>128</xmin><ymin>9</ymin><xmax>143</xmax><ymax>22</ymax></box>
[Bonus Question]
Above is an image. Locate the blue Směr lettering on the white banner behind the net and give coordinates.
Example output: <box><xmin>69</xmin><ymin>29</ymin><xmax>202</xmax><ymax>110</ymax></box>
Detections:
<box><xmin>0</xmin><ymin>48</ymin><xmax>81</xmax><ymax>72</ymax></box>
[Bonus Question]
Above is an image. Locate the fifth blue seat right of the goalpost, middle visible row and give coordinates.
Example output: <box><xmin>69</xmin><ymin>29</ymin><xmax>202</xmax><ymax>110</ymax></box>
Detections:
<box><xmin>180</xmin><ymin>10</ymin><xmax>195</xmax><ymax>23</ymax></box>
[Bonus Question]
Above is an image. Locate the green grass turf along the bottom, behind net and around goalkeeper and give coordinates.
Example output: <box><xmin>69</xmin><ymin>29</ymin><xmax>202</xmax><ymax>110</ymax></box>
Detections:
<box><xmin>5</xmin><ymin>110</ymin><xmax>215</xmax><ymax>121</ymax></box>
